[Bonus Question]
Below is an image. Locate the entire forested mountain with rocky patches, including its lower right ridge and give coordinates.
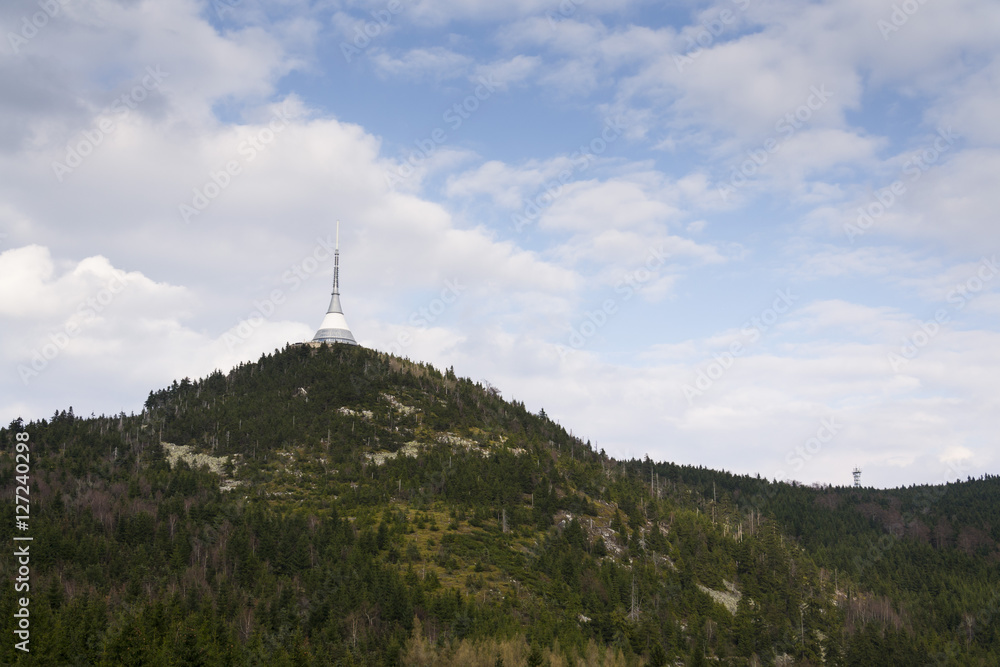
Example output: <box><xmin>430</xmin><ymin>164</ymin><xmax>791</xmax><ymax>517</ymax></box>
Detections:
<box><xmin>0</xmin><ymin>345</ymin><xmax>1000</xmax><ymax>667</ymax></box>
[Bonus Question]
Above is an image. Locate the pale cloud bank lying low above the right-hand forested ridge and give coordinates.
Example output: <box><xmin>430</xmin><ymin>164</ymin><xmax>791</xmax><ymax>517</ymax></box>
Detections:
<box><xmin>424</xmin><ymin>311</ymin><xmax>1000</xmax><ymax>485</ymax></box>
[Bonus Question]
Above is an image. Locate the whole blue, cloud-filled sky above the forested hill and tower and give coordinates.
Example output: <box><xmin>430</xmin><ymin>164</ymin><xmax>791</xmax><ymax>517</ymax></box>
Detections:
<box><xmin>0</xmin><ymin>0</ymin><xmax>1000</xmax><ymax>487</ymax></box>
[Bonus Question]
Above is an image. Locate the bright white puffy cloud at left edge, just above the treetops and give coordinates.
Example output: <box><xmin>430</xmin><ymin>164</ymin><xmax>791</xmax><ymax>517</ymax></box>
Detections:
<box><xmin>0</xmin><ymin>246</ymin><xmax>244</xmax><ymax>415</ymax></box>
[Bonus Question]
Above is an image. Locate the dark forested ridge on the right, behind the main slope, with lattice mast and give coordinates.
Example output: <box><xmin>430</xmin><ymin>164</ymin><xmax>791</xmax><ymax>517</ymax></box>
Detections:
<box><xmin>623</xmin><ymin>458</ymin><xmax>1000</xmax><ymax>665</ymax></box>
